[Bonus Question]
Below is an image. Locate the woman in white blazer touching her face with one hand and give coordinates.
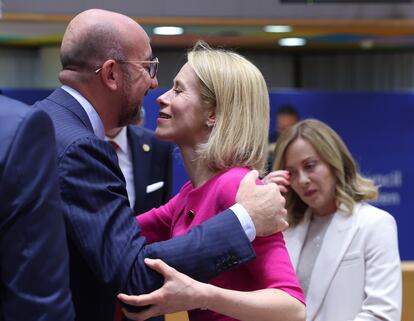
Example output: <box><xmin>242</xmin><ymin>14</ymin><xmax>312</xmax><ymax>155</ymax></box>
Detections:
<box><xmin>264</xmin><ymin>119</ymin><xmax>402</xmax><ymax>321</ymax></box>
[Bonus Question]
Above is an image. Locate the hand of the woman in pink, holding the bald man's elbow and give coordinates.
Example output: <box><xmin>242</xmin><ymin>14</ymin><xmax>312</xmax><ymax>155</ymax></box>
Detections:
<box><xmin>118</xmin><ymin>259</ymin><xmax>211</xmax><ymax>321</ymax></box>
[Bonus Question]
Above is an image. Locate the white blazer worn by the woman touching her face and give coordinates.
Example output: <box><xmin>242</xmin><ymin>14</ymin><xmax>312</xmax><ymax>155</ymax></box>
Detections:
<box><xmin>284</xmin><ymin>203</ymin><xmax>402</xmax><ymax>321</ymax></box>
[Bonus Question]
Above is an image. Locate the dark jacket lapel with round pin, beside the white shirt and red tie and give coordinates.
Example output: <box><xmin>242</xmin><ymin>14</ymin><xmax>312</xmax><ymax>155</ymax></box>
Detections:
<box><xmin>127</xmin><ymin>126</ymin><xmax>152</xmax><ymax>214</ymax></box>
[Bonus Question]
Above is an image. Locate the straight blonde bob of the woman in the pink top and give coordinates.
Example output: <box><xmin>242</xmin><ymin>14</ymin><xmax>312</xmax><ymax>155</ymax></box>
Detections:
<box><xmin>188</xmin><ymin>41</ymin><xmax>269</xmax><ymax>171</ymax></box>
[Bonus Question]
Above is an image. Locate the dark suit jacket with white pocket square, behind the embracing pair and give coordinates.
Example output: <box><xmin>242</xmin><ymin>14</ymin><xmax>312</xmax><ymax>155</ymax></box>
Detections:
<box><xmin>127</xmin><ymin>126</ymin><xmax>173</xmax><ymax>214</ymax></box>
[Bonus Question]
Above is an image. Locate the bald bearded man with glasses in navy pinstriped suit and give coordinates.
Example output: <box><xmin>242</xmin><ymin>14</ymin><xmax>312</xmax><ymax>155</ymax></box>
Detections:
<box><xmin>35</xmin><ymin>9</ymin><xmax>286</xmax><ymax>321</ymax></box>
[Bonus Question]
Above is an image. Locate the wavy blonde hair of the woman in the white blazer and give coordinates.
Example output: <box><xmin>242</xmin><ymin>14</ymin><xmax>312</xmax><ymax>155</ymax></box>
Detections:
<box><xmin>273</xmin><ymin>119</ymin><xmax>378</xmax><ymax>226</ymax></box>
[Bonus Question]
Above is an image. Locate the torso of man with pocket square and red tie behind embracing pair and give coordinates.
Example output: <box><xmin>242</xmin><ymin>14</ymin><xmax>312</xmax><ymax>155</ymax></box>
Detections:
<box><xmin>106</xmin><ymin>125</ymin><xmax>173</xmax><ymax>214</ymax></box>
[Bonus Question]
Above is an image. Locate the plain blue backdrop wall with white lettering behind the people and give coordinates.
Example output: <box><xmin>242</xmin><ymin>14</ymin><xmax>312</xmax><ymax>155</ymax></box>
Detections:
<box><xmin>3</xmin><ymin>89</ymin><xmax>414</xmax><ymax>260</ymax></box>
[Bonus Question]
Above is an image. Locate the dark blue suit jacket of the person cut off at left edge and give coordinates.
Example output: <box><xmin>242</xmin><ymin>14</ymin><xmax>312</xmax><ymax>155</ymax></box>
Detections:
<box><xmin>0</xmin><ymin>96</ymin><xmax>75</xmax><ymax>321</ymax></box>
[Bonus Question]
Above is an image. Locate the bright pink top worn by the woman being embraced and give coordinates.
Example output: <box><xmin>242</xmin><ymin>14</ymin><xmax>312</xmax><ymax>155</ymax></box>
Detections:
<box><xmin>137</xmin><ymin>167</ymin><xmax>305</xmax><ymax>321</ymax></box>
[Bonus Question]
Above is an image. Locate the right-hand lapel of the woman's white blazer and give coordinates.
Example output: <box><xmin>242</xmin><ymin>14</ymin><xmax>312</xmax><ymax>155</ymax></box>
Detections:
<box><xmin>306</xmin><ymin>205</ymin><xmax>358</xmax><ymax>320</ymax></box>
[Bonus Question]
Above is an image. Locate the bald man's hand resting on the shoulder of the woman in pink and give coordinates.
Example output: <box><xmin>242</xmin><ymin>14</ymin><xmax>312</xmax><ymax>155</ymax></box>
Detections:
<box><xmin>236</xmin><ymin>171</ymin><xmax>289</xmax><ymax>236</ymax></box>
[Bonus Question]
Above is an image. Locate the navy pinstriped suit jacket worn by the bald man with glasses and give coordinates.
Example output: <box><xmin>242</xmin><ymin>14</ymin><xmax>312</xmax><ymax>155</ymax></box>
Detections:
<box><xmin>35</xmin><ymin>89</ymin><xmax>255</xmax><ymax>321</ymax></box>
